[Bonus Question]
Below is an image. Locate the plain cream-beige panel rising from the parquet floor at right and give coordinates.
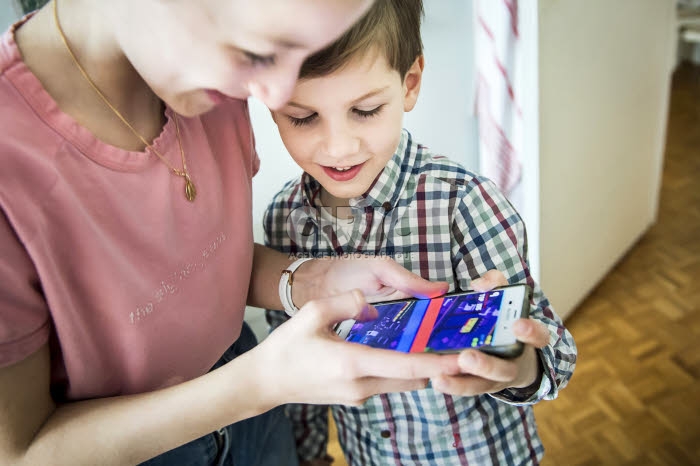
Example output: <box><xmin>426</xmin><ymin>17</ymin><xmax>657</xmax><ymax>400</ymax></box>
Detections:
<box><xmin>539</xmin><ymin>0</ymin><xmax>676</xmax><ymax>316</ymax></box>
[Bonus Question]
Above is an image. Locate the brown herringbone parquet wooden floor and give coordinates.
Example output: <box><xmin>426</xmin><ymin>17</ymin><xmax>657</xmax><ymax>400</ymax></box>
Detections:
<box><xmin>329</xmin><ymin>65</ymin><xmax>700</xmax><ymax>466</ymax></box>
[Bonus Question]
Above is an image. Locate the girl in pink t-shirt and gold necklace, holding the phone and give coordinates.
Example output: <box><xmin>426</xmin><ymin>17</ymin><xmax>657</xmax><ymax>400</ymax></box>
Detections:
<box><xmin>0</xmin><ymin>0</ymin><xmax>546</xmax><ymax>465</ymax></box>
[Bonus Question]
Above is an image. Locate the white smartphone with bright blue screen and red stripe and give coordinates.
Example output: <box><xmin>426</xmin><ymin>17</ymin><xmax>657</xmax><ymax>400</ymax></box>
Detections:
<box><xmin>335</xmin><ymin>285</ymin><xmax>530</xmax><ymax>358</ymax></box>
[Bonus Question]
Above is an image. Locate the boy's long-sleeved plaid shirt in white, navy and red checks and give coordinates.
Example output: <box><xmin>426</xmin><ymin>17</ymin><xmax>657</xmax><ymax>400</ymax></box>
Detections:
<box><xmin>264</xmin><ymin>130</ymin><xmax>576</xmax><ymax>466</ymax></box>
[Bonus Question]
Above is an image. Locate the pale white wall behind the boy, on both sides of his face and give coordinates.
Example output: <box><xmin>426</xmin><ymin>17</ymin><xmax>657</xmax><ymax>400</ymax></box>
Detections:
<box><xmin>246</xmin><ymin>0</ymin><xmax>478</xmax><ymax>339</ymax></box>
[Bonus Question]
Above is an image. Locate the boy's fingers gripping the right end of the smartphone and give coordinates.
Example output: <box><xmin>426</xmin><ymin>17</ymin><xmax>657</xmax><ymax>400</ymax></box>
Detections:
<box><xmin>432</xmin><ymin>270</ymin><xmax>549</xmax><ymax>396</ymax></box>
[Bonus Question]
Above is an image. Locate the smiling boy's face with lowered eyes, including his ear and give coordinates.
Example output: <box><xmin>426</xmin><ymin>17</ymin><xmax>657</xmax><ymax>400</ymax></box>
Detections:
<box><xmin>273</xmin><ymin>46</ymin><xmax>422</xmax><ymax>207</ymax></box>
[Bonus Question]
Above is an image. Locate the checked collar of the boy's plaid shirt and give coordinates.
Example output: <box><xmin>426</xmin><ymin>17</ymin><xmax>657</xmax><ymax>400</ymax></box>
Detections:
<box><xmin>302</xmin><ymin>129</ymin><xmax>421</xmax><ymax>210</ymax></box>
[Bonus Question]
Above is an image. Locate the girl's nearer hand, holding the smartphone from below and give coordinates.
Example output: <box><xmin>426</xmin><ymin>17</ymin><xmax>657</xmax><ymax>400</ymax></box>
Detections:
<box><xmin>243</xmin><ymin>290</ymin><xmax>459</xmax><ymax>407</ymax></box>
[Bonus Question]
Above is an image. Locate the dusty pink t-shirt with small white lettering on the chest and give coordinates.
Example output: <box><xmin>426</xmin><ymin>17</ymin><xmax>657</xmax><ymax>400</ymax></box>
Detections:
<box><xmin>0</xmin><ymin>19</ymin><xmax>259</xmax><ymax>400</ymax></box>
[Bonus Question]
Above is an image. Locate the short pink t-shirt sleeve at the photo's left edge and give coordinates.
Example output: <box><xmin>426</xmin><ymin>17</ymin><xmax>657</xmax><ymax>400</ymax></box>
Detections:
<box><xmin>0</xmin><ymin>210</ymin><xmax>49</xmax><ymax>367</ymax></box>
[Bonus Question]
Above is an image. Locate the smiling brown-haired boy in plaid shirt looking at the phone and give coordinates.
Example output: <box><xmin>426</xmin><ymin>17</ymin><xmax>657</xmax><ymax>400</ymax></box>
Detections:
<box><xmin>264</xmin><ymin>0</ymin><xmax>576</xmax><ymax>466</ymax></box>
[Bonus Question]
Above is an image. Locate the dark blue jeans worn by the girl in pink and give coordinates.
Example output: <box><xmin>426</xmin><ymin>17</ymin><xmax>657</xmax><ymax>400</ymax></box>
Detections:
<box><xmin>141</xmin><ymin>322</ymin><xmax>299</xmax><ymax>466</ymax></box>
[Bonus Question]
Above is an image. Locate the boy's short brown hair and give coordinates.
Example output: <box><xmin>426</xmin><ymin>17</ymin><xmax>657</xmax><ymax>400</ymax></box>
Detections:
<box><xmin>299</xmin><ymin>0</ymin><xmax>423</xmax><ymax>79</ymax></box>
